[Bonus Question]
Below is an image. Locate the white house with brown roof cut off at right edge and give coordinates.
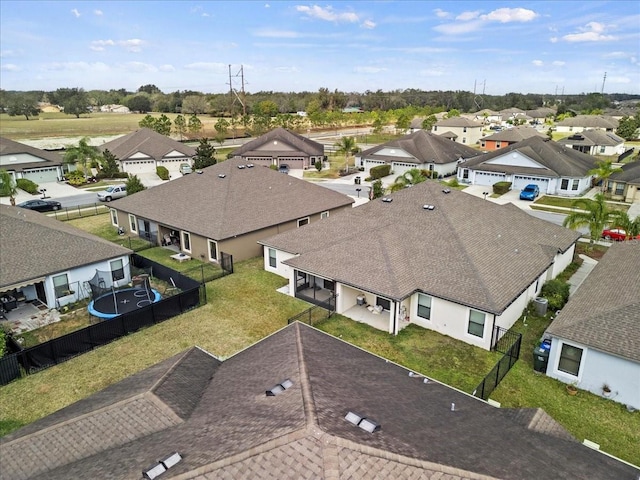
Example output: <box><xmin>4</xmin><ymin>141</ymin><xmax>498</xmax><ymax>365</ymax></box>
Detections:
<box><xmin>546</xmin><ymin>241</ymin><xmax>640</xmax><ymax>410</ymax></box>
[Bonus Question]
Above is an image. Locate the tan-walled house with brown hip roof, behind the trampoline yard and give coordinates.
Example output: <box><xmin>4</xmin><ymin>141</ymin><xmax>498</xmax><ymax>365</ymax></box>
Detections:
<box><xmin>111</xmin><ymin>159</ymin><xmax>354</xmax><ymax>262</ymax></box>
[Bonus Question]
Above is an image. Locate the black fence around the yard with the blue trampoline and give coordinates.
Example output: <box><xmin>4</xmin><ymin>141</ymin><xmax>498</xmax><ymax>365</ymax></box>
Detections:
<box><xmin>0</xmin><ymin>254</ymin><xmax>204</xmax><ymax>385</ymax></box>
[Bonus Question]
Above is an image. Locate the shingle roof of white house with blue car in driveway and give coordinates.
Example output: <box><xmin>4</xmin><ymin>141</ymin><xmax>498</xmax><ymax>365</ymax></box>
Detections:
<box><xmin>464</xmin><ymin>136</ymin><xmax>597</xmax><ymax>177</ymax></box>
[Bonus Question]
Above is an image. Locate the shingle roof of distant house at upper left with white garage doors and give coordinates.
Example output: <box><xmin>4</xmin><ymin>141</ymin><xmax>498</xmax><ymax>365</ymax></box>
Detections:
<box><xmin>98</xmin><ymin>128</ymin><xmax>196</xmax><ymax>161</ymax></box>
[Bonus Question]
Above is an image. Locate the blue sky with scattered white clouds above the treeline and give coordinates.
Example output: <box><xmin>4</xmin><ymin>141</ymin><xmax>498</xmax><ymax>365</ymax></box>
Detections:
<box><xmin>0</xmin><ymin>0</ymin><xmax>640</xmax><ymax>95</ymax></box>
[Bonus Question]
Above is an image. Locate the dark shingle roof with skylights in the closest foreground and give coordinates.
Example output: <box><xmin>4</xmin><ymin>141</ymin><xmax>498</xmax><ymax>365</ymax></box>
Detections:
<box><xmin>0</xmin><ymin>322</ymin><xmax>638</xmax><ymax>480</ymax></box>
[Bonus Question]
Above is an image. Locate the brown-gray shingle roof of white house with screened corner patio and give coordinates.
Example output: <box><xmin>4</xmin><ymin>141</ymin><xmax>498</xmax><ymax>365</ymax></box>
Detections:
<box><xmin>260</xmin><ymin>181</ymin><xmax>580</xmax><ymax>313</ymax></box>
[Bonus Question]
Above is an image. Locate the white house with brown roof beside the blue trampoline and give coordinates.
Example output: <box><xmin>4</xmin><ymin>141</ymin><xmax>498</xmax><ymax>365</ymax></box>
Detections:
<box><xmin>0</xmin><ymin>205</ymin><xmax>131</xmax><ymax>308</ymax></box>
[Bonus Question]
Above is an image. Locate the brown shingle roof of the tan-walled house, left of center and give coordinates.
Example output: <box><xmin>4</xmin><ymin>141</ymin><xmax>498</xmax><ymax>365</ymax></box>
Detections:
<box><xmin>112</xmin><ymin>159</ymin><xmax>353</xmax><ymax>240</ymax></box>
